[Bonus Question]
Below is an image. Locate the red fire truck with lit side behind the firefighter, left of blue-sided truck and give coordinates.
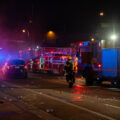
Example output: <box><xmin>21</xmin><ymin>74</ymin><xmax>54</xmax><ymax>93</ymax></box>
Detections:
<box><xmin>32</xmin><ymin>48</ymin><xmax>71</xmax><ymax>74</ymax></box>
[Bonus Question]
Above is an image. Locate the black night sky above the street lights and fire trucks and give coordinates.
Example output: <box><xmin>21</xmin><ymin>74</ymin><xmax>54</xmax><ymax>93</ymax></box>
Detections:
<box><xmin>0</xmin><ymin>0</ymin><xmax>120</xmax><ymax>44</ymax></box>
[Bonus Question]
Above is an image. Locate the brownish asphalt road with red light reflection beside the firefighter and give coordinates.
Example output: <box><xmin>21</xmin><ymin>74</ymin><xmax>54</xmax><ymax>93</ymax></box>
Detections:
<box><xmin>0</xmin><ymin>73</ymin><xmax>120</xmax><ymax>120</ymax></box>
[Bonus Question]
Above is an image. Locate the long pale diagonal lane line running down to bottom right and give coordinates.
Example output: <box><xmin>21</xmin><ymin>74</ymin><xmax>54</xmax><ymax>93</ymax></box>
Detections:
<box><xmin>1</xmin><ymin>83</ymin><xmax>116</xmax><ymax>120</ymax></box>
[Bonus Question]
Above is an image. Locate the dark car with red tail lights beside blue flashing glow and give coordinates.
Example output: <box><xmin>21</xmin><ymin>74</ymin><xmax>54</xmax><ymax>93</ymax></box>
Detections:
<box><xmin>4</xmin><ymin>59</ymin><xmax>27</xmax><ymax>78</ymax></box>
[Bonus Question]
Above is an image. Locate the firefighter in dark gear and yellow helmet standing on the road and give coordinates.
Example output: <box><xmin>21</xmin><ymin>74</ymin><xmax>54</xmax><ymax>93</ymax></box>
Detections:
<box><xmin>64</xmin><ymin>56</ymin><xmax>75</xmax><ymax>88</ymax></box>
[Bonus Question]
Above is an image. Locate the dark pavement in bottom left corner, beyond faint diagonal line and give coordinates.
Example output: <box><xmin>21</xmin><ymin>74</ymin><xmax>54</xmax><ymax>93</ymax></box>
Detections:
<box><xmin>0</xmin><ymin>100</ymin><xmax>40</xmax><ymax>120</ymax></box>
